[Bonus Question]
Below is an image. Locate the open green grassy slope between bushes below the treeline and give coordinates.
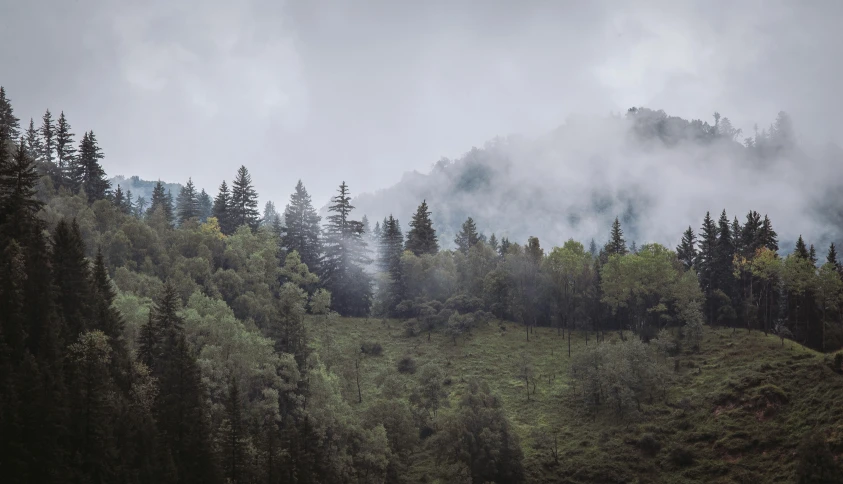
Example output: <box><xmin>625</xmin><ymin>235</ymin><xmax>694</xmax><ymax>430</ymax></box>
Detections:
<box><xmin>311</xmin><ymin>318</ymin><xmax>843</xmax><ymax>484</ymax></box>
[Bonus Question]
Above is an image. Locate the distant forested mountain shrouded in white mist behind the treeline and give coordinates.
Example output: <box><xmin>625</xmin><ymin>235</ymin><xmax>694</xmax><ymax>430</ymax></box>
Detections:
<box><xmin>353</xmin><ymin>108</ymin><xmax>843</xmax><ymax>253</ymax></box>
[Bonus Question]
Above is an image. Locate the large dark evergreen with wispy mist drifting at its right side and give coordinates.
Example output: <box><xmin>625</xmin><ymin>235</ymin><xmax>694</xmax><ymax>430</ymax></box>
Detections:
<box><xmin>321</xmin><ymin>182</ymin><xmax>372</xmax><ymax>316</ymax></box>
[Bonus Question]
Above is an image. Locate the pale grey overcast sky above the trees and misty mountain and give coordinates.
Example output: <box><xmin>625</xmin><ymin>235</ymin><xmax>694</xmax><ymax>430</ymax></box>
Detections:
<box><xmin>0</xmin><ymin>0</ymin><xmax>843</xmax><ymax>207</ymax></box>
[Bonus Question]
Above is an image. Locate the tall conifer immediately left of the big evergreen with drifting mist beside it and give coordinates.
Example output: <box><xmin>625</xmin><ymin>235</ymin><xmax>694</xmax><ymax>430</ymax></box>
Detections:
<box><xmin>284</xmin><ymin>180</ymin><xmax>322</xmax><ymax>272</ymax></box>
